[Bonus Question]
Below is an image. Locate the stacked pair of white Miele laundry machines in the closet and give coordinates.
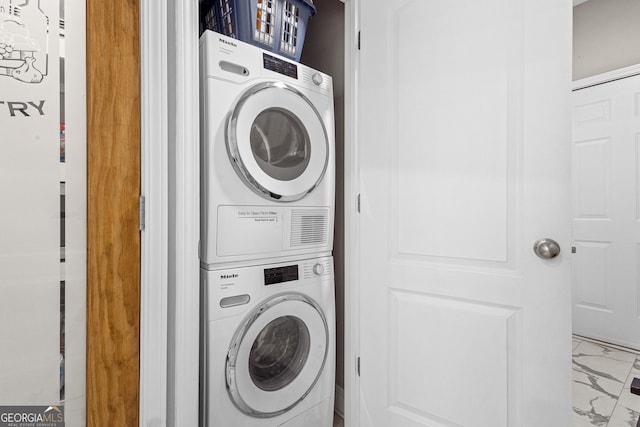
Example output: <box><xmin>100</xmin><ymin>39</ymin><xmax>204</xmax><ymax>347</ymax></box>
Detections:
<box><xmin>200</xmin><ymin>31</ymin><xmax>335</xmax><ymax>427</ymax></box>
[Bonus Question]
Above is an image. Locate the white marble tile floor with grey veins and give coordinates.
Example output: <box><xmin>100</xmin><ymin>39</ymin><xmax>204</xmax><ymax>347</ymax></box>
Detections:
<box><xmin>572</xmin><ymin>336</ymin><xmax>640</xmax><ymax>427</ymax></box>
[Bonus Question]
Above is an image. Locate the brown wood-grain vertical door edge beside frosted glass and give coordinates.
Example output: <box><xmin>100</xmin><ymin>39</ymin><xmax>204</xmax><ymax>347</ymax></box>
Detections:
<box><xmin>87</xmin><ymin>0</ymin><xmax>140</xmax><ymax>427</ymax></box>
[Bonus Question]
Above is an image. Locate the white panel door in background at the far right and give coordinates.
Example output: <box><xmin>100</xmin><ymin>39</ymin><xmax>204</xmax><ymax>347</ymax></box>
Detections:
<box><xmin>571</xmin><ymin>76</ymin><xmax>640</xmax><ymax>350</ymax></box>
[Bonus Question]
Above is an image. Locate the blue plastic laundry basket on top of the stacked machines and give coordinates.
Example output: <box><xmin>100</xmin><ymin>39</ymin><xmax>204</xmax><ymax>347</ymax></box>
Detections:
<box><xmin>200</xmin><ymin>0</ymin><xmax>316</xmax><ymax>61</ymax></box>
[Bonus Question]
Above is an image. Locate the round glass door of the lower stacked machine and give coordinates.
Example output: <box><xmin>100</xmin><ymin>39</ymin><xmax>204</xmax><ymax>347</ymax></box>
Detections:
<box><xmin>226</xmin><ymin>293</ymin><xmax>329</xmax><ymax>418</ymax></box>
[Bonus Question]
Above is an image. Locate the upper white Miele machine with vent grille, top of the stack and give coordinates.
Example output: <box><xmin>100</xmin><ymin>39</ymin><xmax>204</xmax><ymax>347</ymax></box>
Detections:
<box><xmin>200</xmin><ymin>31</ymin><xmax>335</xmax><ymax>269</ymax></box>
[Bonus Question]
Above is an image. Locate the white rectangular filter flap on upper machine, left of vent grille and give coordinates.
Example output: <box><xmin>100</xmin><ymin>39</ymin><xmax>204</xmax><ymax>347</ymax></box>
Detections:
<box><xmin>216</xmin><ymin>206</ymin><xmax>283</xmax><ymax>256</ymax></box>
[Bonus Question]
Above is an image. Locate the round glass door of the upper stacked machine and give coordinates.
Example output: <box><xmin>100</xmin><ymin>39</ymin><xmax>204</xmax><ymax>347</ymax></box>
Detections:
<box><xmin>227</xmin><ymin>82</ymin><xmax>329</xmax><ymax>201</ymax></box>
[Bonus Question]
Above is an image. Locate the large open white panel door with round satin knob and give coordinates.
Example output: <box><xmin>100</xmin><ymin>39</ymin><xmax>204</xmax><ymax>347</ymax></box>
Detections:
<box><xmin>357</xmin><ymin>0</ymin><xmax>571</xmax><ymax>427</ymax></box>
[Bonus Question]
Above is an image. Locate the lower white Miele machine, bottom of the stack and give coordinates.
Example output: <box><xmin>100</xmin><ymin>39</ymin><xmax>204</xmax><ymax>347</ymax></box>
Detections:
<box><xmin>201</xmin><ymin>257</ymin><xmax>335</xmax><ymax>427</ymax></box>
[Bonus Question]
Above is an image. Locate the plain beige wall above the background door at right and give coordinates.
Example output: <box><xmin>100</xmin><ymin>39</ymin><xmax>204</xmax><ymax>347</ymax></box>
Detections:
<box><xmin>573</xmin><ymin>0</ymin><xmax>640</xmax><ymax>80</ymax></box>
